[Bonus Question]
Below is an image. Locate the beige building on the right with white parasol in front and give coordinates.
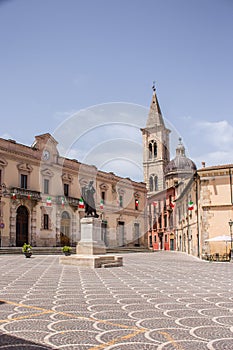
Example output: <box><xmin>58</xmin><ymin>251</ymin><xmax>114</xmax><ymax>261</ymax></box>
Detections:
<box><xmin>175</xmin><ymin>164</ymin><xmax>233</xmax><ymax>260</ymax></box>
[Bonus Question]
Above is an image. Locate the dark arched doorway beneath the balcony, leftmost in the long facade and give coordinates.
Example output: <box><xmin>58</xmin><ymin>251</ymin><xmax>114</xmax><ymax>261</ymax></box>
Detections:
<box><xmin>16</xmin><ymin>205</ymin><xmax>29</xmax><ymax>247</ymax></box>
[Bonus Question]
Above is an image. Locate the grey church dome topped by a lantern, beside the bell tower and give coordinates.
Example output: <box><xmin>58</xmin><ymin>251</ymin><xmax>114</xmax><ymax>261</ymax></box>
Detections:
<box><xmin>165</xmin><ymin>138</ymin><xmax>197</xmax><ymax>177</ymax></box>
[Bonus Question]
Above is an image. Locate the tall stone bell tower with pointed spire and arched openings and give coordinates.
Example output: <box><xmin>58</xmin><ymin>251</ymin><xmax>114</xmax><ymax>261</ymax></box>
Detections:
<box><xmin>141</xmin><ymin>84</ymin><xmax>170</xmax><ymax>196</ymax></box>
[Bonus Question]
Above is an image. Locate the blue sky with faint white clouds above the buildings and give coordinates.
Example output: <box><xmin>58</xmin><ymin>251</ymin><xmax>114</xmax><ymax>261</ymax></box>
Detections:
<box><xmin>0</xmin><ymin>0</ymin><xmax>233</xmax><ymax>180</ymax></box>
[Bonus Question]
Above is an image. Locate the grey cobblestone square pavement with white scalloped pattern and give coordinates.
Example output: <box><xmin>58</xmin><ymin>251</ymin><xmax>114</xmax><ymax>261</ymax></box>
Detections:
<box><xmin>0</xmin><ymin>252</ymin><xmax>233</xmax><ymax>350</ymax></box>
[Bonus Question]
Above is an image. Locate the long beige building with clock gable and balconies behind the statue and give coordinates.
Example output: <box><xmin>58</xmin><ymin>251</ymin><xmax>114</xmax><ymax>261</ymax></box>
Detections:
<box><xmin>0</xmin><ymin>133</ymin><xmax>147</xmax><ymax>248</ymax></box>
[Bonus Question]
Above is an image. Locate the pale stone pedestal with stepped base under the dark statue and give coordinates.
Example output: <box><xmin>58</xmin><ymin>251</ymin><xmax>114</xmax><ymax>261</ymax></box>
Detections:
<box><xmin>60</xmin><ymin>217</ymin><xmax>123</xmax><ymax>268</ymax></box>
